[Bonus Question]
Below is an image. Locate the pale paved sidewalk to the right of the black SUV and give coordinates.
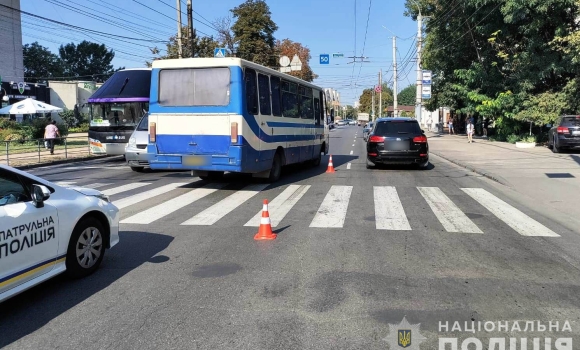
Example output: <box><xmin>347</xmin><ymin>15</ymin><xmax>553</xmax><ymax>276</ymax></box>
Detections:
<box><xmin>427</xmin><ymin>132</ymin><xmax>580</xmax><ymax>224</ymax></box>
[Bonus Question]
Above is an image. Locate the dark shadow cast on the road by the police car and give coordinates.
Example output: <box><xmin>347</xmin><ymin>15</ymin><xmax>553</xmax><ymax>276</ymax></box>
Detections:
<box><xmin>0</xmin><ymin>231</ymin><xmax>173</xmax><ymax>348</ymax></box>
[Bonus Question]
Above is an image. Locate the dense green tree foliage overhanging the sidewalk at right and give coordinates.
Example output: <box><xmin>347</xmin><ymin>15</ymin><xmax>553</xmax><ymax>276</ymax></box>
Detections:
<box><xmin>406</xmin><ymin>0</ymin><xmax>580</xmax><ymax>134</ymax></box>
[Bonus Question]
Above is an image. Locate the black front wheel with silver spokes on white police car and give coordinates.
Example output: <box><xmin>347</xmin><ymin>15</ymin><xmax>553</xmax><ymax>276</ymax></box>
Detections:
<box><xmin>66</xmin><ymin>218</ymin><xmax>105</xmax><ymax>278</ymax></box>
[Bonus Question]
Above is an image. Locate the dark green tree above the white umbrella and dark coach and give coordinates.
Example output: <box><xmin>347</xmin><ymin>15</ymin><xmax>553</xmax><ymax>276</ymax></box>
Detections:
<box><xmin>58</xmin><ymin>40</ymin><xmax>115</xmax><ymax>80</ymax></box>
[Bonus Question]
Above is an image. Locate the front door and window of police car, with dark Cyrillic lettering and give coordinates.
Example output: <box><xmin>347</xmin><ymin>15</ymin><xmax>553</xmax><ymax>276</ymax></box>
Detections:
<box><xmin>0</xmin><ymin>169</ymin><xmax>58</xmax><ymax>293</ymax></box>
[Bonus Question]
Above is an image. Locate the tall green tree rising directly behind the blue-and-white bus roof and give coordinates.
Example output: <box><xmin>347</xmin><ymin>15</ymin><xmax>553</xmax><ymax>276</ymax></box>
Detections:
<box><xmin>230</xmin><ymin>0</ymin><xmax>278</xmax><ymax>67</ymax></box>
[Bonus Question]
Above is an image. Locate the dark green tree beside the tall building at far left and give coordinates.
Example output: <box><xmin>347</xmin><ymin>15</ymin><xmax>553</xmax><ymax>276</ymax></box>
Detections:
<box><xmin>22</xmin><ymin>41</ymin><xmax>63</xmax><ymax>83</ymax></box>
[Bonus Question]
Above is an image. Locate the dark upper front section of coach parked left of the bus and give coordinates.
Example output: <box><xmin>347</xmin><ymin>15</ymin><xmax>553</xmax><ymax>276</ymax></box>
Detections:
<box><xmin>88</xmin><ymin>68</ymin><xmax>151</xmax><ymax>103</ymax></box>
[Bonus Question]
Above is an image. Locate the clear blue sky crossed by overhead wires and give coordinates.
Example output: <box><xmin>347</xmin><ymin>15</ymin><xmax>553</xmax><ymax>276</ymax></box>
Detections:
<box><xmin>21</xmin><ymin>0</ymin><xmax>417</xmax><ymax>104</ymax></box>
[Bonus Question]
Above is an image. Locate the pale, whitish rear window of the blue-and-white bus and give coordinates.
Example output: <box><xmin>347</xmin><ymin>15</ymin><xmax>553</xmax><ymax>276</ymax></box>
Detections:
<box><xmin>159</xmin><ymin>68</ymin><xmax>230</xmax><ymax>107</ymax></box>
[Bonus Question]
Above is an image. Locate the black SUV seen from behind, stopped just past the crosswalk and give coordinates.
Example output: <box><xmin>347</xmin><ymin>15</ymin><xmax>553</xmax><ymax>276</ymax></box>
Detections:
<box><xmin>367</xmin><ymin>118</ymin><xmax>429</xmax><ymax>169</ymax></box>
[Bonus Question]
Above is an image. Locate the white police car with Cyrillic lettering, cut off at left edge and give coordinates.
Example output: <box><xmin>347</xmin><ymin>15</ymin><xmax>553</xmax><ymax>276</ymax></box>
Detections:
<box><xmin>0</xmin><ymin>165</ymin><xmax>119</xmax><ymax>302</ymax></box>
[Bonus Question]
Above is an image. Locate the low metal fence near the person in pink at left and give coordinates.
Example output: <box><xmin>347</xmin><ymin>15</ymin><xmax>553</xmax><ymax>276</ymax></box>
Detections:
<box><xmin>0</xmin><ymin>136</ymin><xmax>92</xmax><ymax>166</ymax></box>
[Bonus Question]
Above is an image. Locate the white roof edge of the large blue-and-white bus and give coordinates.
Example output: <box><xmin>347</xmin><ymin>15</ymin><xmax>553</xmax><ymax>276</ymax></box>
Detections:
<box><xmin>153</xmin><ymin>57</ymin><xmax>323</xmax><ymax>90</ymax></box>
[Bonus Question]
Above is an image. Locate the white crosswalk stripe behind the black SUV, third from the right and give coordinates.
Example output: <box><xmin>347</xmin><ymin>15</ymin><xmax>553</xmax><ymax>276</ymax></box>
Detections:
<box><xmin>374</xmin><ymin>186</ymin><xmax>411</xmax><ymax>231</ymax></box>
